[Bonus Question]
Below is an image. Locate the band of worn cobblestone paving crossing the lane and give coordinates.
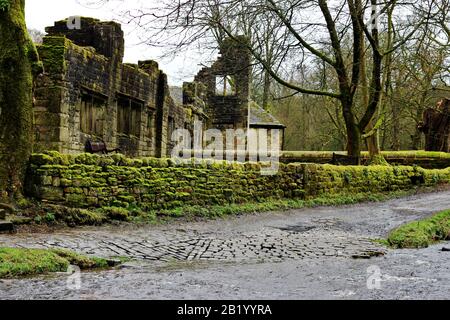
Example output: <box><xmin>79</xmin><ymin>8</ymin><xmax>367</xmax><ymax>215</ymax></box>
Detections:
<box><xmin>0</xmin><ymin>219</ymin><xmax>384</xmax><ymax>262</ymax></box>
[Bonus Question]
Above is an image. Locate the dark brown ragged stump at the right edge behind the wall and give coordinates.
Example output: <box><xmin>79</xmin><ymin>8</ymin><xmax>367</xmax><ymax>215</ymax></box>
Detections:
<box><xmin>419</xmin><ymin>98</ymin><xmax>450</xmax><ymax>152</ymax></box>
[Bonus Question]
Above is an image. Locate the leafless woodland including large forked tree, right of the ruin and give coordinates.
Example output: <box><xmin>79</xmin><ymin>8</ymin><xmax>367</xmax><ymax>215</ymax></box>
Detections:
<box><xmin>93</xmin><ymin>0</ymin><xmax>450</xmax><ymax>159</ymax></box>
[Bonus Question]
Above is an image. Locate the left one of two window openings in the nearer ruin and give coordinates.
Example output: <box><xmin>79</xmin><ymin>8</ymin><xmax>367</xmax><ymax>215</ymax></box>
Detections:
<box><xmin>80</xmin><ymin>93</ymin><xmax>106</xmax><ymax>136</ymax></box>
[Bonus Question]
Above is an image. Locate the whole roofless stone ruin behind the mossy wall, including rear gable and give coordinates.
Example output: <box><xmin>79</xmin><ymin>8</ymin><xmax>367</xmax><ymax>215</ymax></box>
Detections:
<box><xmin>34</xmin><ymin>18</ymin><xmax>284</xmax><ymax>157</ymax></box>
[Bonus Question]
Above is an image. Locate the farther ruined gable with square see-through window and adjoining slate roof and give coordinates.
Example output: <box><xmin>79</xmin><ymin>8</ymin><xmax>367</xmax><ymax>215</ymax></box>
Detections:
<box><xmin>183</xmin><ymin>36</ymin><xmax>285</xmax><ymax>149</ymax></box>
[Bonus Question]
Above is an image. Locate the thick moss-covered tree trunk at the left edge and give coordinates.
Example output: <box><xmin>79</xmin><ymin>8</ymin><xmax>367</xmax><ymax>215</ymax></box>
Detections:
<box><xmin>0</xmin><ymin>0</ymin><xmax>38</xmax><ymax>202</ymax></box>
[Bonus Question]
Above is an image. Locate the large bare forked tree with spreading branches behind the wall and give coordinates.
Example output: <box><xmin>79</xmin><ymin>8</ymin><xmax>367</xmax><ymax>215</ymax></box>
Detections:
<box><xmin>95</xmin><ymin>0</ymin><xmax>436</xmax><ymax>161</ymax></box>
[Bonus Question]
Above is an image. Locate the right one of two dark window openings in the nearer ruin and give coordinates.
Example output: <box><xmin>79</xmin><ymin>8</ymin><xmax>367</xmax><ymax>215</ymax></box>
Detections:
<box><xmin>117</xmin><ymin>96</ymin><xmax>144</xmax><ymax>137</ymax></box>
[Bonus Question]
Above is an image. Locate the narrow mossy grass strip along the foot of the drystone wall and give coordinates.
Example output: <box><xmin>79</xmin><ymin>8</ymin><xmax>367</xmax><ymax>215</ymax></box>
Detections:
<box><xmin>13</xmin><ymin>188</ymin><xmax>436</xmax><ymax>231</ymax></box>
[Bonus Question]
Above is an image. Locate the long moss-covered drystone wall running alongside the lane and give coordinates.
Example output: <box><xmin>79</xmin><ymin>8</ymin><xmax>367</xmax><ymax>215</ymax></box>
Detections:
<box><xmin>27</xmin><ymin>152</ymin><xmax>450</xmax><ymax>210</ymax></box>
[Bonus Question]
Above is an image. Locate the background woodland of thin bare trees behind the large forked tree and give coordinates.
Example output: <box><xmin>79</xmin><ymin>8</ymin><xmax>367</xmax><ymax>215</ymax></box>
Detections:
<box><xmin>239</xmin><ymin>1</ymin><xmax>450</xmax><ymax>151</ymax></box>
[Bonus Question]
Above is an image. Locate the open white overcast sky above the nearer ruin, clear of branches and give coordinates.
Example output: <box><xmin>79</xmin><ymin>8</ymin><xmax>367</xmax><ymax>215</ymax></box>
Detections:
<box><xmin>26</xmin><ymin>0</ymin><xmax>205</xmax><ymax>85</ymax></box>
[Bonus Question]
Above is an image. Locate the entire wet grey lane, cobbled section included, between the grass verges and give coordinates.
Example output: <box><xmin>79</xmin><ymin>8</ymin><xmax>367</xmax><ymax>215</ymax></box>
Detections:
<box><xmin>0</xmin><ymin>191</ymin><xmax>450</xmax><ymax>299</ymax></box>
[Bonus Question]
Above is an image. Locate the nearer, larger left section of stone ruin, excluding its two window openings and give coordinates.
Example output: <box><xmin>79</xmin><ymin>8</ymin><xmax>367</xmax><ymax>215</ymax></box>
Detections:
<box><xmin>35</xmin><ymin>18</ymin><xmax>185</xmax><ymax>157</ymax></box>
